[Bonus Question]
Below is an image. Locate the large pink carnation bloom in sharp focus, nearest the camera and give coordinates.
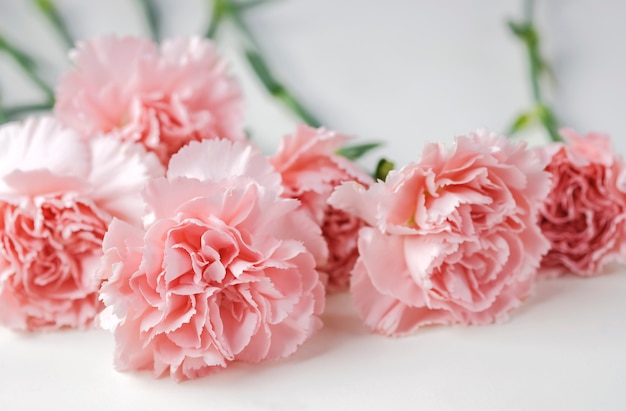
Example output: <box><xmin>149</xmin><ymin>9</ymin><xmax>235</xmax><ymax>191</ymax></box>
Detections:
<box><xmin>101</xmin><ymin>140</ymin><xmax>324</xmax><ymax>380</ymax></box>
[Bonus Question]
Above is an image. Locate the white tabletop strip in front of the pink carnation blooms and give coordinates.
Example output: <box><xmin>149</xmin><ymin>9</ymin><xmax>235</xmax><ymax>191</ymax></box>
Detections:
<box><xmin>0</xmin><ymin>270</ymin><xmax>626</xmax><ymax>411</ymax></box>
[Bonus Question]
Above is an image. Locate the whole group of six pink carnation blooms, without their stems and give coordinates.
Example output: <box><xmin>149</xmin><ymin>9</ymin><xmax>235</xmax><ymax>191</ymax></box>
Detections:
<box><xmin>0</xmin><ymin>3</ymin><xmax>626</xmax><ymax>380</ymax></box>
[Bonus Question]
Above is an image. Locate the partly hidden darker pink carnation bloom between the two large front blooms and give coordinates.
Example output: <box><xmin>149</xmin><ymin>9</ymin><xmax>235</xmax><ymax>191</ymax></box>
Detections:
<box><xmin>270</xmin><ymin>125</ymin><xmax>373</xmax><ymax>292</ymax></box>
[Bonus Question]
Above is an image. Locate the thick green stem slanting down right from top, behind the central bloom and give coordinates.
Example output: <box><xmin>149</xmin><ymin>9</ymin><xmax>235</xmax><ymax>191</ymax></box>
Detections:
<box><xmin>206</xmin><ymin>0</ymin><xmax>321</xmax><ymax>127</ymax></box>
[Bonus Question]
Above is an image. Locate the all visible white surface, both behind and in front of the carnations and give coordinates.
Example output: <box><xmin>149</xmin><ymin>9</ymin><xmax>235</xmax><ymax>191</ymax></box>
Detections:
<box><xmin>0</xmin><ymin>0</ymin><xmax>626</xmax><ymax>410</ymax></box>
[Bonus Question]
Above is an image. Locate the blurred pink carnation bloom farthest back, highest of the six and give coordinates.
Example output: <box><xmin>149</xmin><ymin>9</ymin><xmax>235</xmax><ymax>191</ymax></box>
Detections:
<box><xmin>55</xmin><ymin>36</ymin><xmax>244</xmax><ymax>165</ymax></box>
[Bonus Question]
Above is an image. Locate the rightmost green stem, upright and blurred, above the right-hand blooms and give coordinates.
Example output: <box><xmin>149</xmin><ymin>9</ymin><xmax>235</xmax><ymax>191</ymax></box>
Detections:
<box><xmin>509</xmin><ymin>0</ymin><xmax>563</xmax><ymax>142</ymax></box>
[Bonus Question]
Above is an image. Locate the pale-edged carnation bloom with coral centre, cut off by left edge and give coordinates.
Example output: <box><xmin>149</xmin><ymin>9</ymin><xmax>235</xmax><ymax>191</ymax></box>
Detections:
<box><xmin>0</xmin><ymin>118</ymin><xmax>163</xmax><ymax>331</ymax></box>
